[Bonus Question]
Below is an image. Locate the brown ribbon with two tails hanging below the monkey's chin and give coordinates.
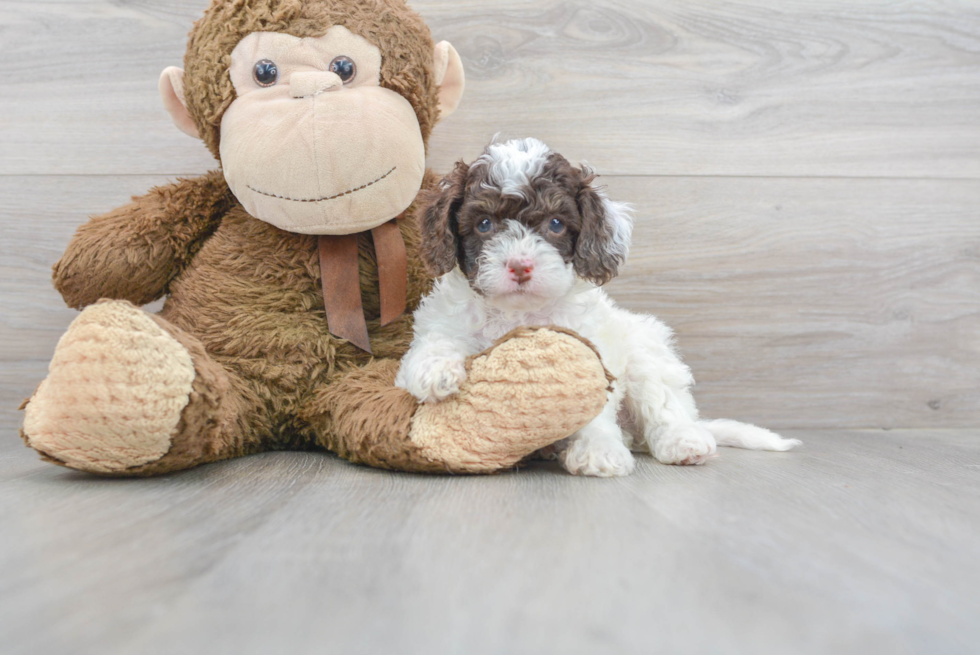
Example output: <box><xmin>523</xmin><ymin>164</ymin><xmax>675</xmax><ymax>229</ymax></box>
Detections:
<box><xmin>319</xmin><ymin>214</ymin><xmax>408</xmax><ymax>352</ymax></box>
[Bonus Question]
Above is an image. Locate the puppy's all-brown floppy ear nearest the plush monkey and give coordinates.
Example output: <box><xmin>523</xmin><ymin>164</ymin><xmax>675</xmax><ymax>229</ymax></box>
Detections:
<box><xmin>418</xmin><ymin>161</ymin><xmax>470</xmax><ymax>277</ymax></box>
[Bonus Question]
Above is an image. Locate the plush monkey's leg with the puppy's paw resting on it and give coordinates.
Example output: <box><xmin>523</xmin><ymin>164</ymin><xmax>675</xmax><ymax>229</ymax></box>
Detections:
<box><xmin>301</xmin><ymin>329</ymin><xmax>609</xmax><ymax>473</ymax></box>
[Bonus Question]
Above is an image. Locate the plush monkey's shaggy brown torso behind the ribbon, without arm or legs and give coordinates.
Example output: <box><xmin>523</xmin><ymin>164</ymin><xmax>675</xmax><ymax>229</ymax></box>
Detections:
<box><xmin>153</xmin><ymin>176</ymin><xmax>431</xmax><ymax>456</ymax></box>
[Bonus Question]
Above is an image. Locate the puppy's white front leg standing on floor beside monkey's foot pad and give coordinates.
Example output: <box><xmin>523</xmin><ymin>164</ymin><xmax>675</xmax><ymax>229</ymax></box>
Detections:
<box><xmin>558</xmin><ymin>403</ymin><xmax>636</xmax><ymax>478</ymax></box>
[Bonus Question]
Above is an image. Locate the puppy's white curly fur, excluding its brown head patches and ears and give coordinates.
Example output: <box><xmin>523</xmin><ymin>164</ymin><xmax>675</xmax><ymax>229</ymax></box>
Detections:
<box><xmin>395</xmin><ymin>142</ymin><xmax>800</xmax><ymax>477</ymax></box>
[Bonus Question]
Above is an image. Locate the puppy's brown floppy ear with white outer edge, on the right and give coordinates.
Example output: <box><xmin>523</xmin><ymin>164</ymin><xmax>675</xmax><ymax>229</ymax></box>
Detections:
<box><xmin>574</xmin><ymin>166</ymin><xmax>633</xmax><ymax>286</ymax></box>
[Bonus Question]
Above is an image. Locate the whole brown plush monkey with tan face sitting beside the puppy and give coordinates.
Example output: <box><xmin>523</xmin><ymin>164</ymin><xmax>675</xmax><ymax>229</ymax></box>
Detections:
<box><xmin>22</xmin><ymin>0</ymin><xmax>608</xmax><ymax>475</ymax></box>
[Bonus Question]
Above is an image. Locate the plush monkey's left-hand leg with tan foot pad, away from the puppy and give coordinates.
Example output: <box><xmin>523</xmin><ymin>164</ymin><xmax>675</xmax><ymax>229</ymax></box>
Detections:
<box><xmin>21</xmin><ymin>300</ymin><xmax>260</xmax><ymax>476</ymax></box>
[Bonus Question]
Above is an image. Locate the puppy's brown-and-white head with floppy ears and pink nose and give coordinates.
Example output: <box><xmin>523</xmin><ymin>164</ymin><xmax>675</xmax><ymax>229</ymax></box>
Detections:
<box><xmin>421</xmin><ymin>139</ymin><xmax>633</xmax><ymax>309</ymax></box>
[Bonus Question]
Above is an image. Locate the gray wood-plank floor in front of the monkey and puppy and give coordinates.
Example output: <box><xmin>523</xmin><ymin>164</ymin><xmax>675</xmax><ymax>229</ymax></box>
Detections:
<box><xmin>0</xmin><ymin>430</ymin><xmax>980</xmax><ymax>655</ymax></box>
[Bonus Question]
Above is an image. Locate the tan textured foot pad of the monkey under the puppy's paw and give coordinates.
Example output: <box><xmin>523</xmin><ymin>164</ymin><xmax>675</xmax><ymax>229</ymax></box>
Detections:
<box><xmin>411</xmin><ymin>328</ymin><xmax>611</xmax><ymax>473</ymax></box>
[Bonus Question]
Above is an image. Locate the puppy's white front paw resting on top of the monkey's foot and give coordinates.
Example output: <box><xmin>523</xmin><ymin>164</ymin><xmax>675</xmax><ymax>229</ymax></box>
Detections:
<box><xmin>395</xmin><ymin>335</ymin><xmax>466</xmax><ymax>403</ymax></box>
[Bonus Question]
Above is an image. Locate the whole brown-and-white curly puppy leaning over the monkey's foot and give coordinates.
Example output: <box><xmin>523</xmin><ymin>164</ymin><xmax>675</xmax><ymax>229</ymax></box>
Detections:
<box><xmin>395</xmin><ymin>139</ymin><xmax>800</xmax><ymax>476</ymax></box>
